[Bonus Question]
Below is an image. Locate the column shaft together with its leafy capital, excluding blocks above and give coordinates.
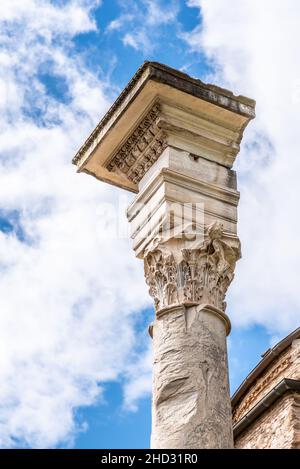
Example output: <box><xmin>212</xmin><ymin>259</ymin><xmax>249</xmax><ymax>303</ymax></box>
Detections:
<box><xmin>145</xmin><ymin>222</ymin><xmax>239</xmax><ymax>448</ymax></box>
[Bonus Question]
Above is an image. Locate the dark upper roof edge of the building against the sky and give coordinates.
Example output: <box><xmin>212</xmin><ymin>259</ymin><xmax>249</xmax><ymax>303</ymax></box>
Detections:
<box><xmin>231</xmin><ymin>327</ymin><xmax>300</xmax><ymax>408</ymax></box>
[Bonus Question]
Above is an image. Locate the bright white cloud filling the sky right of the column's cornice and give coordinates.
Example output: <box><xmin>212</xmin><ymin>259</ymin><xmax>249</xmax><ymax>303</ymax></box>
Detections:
<box><xmin>186</xmin><ymin>0</ymin><xmax>300</xmax><ymax>333</ymax></box>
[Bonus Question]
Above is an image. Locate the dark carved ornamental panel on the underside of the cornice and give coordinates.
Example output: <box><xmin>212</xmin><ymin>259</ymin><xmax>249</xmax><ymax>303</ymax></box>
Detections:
<box><xmin>107</xmin><ymin>103</ymin><xmax>167</xmax><ymax>184</ymax></box>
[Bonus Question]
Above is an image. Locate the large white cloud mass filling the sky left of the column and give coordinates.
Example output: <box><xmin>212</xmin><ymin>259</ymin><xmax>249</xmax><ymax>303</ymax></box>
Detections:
<box><xmin>0</xmin><ymin>0</ymin><xmax>150</xmax><ymax>448</ymax></box>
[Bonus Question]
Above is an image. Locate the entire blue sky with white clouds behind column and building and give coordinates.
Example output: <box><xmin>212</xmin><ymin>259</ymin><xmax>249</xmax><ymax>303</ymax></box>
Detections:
<box><xmin>0</xmin><ymin>0</ymin><xmax>300</xmax><ymax>448</ymax></box>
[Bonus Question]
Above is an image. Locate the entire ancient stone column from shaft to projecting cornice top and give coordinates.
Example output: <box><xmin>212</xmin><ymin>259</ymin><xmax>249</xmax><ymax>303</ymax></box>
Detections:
<box><xmin>73</xmin><ymin>62</ymin><xmax>255</xmax><ymax>449</ymax></box>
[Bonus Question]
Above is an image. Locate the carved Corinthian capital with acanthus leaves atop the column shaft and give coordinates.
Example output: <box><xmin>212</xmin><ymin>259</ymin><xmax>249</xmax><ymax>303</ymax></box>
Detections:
<box><xmin>144</xmin><ymin>222</ymin><xmax>240</xmax><ymax>314</ymax></box>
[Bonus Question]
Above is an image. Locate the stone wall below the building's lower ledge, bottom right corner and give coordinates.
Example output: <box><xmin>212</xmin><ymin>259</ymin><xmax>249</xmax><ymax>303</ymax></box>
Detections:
<box><xmin>235</xmin><ymin>393</ymin><xmax>300</xmax><ymax>449</ymax></box>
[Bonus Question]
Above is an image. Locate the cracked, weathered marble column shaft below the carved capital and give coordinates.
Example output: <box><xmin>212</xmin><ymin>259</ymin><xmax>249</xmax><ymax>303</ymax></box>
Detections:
<box><xmin>151</xmin><ymin>306</ymin><xmax>233</xmax><ymax>449</ymax></box>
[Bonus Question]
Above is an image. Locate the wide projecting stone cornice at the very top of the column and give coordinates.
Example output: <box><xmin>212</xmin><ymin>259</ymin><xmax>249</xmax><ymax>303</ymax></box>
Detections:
<box><xmin>73</xmin><ymin>62</ymin><xmax>255</xmax><ymax>192</ymax></box>
